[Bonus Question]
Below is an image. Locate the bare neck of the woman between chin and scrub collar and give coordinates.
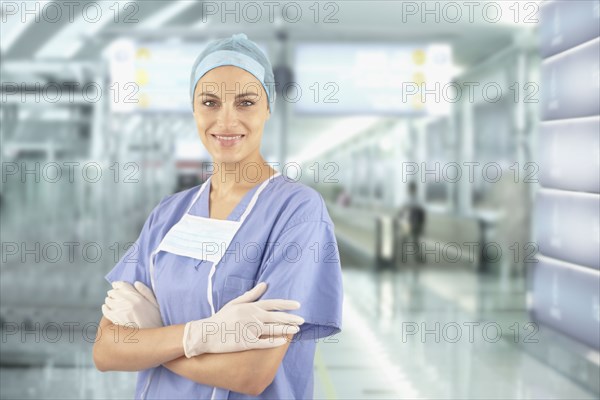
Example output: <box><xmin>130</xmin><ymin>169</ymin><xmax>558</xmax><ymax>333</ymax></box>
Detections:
<box><xmin>210</xmin><ymin>154</ymin><xmax>276</xmax><ymax>196</ymax></box>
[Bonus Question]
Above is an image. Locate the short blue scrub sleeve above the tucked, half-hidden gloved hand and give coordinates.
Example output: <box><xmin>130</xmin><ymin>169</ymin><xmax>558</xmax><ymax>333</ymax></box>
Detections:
<box><xmin>105</xmin><ymin>205</ymin><xmax>160</xmax><ymax>287</ymax></box>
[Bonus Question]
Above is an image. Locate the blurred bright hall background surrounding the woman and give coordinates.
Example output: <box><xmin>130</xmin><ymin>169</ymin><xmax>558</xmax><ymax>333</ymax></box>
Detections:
<box><xmin>0</xmin><ymin>0</ymin><xmax>600</xmax><ymax>399</ymax></box>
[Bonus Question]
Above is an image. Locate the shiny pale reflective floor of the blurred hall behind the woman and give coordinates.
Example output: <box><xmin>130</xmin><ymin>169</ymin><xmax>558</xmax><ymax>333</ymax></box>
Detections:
<box><xmin>0</xmin><ymin>267</ymin><xmax>598</xmax><ymax>399</ymax></box>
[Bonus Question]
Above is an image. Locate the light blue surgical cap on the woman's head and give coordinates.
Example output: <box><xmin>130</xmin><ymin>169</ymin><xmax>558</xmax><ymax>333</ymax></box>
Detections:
<box><xmin>190</xmin><ymin>33</ymin><xmax>275</xmax><ymax>113</ymax></box>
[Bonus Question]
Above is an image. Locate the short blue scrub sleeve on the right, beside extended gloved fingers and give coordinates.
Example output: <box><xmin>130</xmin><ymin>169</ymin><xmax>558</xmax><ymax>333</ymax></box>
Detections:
<box><xmin>257</xmin><ymin>221</ymin><xmax>343</xmax><ymax>340</ymax></box>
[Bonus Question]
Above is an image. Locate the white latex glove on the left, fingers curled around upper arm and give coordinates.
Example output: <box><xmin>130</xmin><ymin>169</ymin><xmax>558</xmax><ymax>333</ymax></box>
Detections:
<box><xmin>102</xmin><ymin>281</ymin><xmax>163</xmax><ymax>329</ymax></box>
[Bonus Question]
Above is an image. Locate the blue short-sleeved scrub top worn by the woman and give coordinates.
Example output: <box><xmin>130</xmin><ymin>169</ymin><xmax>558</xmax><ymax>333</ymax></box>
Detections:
<box><xmin>106</xmin><ymin>175</ymin><xmax>343</xmax><ymax>399</ymax></box>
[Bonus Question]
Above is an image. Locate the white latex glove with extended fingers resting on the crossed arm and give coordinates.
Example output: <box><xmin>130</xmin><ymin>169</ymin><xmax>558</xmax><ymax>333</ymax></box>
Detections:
<box><xmin>183</xmin><ymin>282</ymin><xmax>304</xmax><ymax>358</ymax></box>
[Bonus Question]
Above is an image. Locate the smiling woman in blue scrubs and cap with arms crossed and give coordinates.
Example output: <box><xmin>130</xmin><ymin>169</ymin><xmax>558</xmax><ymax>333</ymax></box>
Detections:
<box><xmin>94</xmin><ymin>34</ymin><xmax>342</xmax><ymax>399</ymax></box>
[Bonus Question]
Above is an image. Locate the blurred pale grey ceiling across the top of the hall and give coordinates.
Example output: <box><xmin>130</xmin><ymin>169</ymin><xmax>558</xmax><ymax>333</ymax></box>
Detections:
<box><xmin>2</xmin><ymin>0</ymin><xmax>515</xmax><ymax>65</ymax></box>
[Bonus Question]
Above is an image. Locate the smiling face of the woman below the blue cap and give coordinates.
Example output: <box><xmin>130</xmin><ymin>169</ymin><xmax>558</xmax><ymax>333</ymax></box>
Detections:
<box><xmin>194</xmin><ymin>65</ymin><xmax>270</xmax><ymax>164</ymax></box>
